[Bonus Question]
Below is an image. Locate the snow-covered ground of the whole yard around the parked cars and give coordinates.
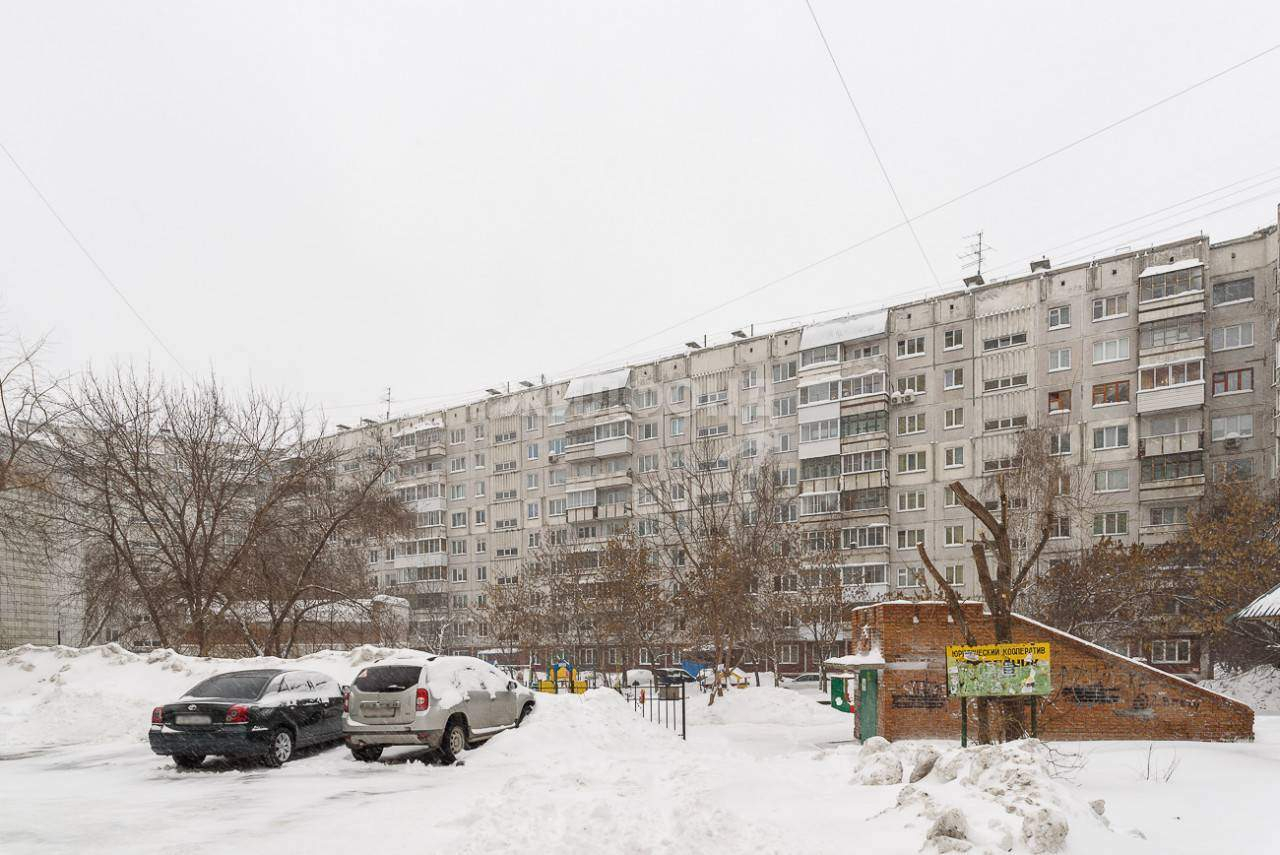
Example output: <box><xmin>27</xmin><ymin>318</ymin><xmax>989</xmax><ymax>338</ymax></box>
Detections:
<box><xmin>0</xmin><ymin>648</ymin><xmax>1280</xmax><ymax>855</ymax></box>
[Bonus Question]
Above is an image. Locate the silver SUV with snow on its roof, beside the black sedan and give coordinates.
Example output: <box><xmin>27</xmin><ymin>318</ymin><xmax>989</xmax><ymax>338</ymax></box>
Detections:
<box><xmin>342</xmin><ymin>657</ymin><xmax>535</xmax><ymax>762</ymax></box>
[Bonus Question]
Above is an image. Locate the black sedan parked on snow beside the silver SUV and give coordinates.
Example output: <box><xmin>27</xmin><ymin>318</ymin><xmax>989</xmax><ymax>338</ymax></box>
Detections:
<box><xmin>150</xmin><ymin>668</ymin><xmax>342</xmax><ymax>768</ymax></box>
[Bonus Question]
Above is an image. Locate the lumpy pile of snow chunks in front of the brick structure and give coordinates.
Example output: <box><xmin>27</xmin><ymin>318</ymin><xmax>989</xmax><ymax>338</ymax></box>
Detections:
<box><xmin>850</xmin><ymin>736</ymin><xmax>1126</xmax><ymax>854</ymax></box>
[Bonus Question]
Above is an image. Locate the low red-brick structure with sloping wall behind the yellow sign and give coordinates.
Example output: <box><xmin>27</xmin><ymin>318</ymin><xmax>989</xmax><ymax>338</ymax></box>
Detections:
<box><xmin>850</xmin><ymin>602</ymin><xmax>1253</xmax><ymax>741</ymax></box>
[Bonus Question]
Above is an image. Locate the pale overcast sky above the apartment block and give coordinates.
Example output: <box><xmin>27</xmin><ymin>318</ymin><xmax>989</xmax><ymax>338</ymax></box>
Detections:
<box><xmin>0</xmin><ymin>0</ymin><xmax>1280</xmax><ymax>421</ymax></box>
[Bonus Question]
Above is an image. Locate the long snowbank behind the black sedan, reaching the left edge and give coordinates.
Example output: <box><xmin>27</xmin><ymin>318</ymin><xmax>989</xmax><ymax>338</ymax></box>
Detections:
<box><xmin>0</xmin><ymin>644</ymin><xmax>428</xmax><ymax>749</ymax></box>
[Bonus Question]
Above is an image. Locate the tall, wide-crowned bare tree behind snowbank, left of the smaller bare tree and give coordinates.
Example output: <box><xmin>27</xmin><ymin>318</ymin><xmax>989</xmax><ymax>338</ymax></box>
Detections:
<box><xmin>52</xmin><ymin>371</ymin><xmax>381</xmax><ymax>654</ymax></box>
